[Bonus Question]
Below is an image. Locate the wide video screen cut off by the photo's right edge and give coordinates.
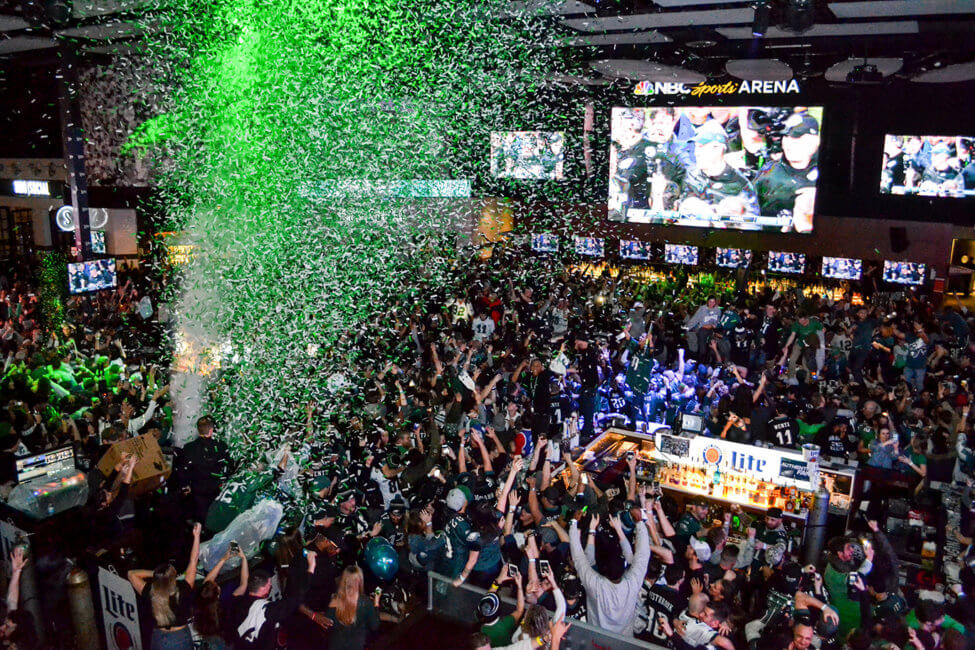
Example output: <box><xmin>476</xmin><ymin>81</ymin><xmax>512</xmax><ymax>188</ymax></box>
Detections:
<box><xmin>880</xmin><ymin>134</ymin><xmax>975</xmax><ymax>198</ymax></box>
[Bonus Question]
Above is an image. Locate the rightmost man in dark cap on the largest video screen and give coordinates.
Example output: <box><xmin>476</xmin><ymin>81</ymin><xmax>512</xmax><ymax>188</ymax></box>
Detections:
<box><xmin>755</xmin><ymin>113</ymin><xmax>819</xmax><ymax>232</ymax></box>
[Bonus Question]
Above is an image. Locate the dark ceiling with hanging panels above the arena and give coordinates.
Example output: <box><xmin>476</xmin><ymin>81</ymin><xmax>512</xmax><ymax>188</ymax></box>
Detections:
<box><xmin>0</xmin><ymin>0</ymin><xmax>975</xmax><ymax>83</ymax></box>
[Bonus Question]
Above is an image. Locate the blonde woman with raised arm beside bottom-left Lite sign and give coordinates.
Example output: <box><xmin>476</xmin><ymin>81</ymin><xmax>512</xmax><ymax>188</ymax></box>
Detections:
<box><xmin>129</xmin><ymin>524</ymin><xmax>202</xmax><ymax>650</ymax></box>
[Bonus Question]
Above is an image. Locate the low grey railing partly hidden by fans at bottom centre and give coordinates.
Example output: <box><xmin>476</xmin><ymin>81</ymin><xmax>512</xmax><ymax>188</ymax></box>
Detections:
<box><xmin>427</xmin><ymin>571</ymin><xmax>664</xmax><ymax>650</ymax></box>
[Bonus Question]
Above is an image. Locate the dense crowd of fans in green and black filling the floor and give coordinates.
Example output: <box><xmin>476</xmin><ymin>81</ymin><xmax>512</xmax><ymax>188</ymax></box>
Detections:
<box><xmin>0</xmin><ymin>248</ymin><xmax>975</xmax><ymax>650</ymax></box>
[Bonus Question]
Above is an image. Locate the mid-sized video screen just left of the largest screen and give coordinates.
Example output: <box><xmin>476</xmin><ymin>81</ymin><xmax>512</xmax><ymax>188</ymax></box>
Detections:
<box><xmin>491</xmin><ymin>131</ymin><xmax>565</xmax><ymax>180</ymax></box>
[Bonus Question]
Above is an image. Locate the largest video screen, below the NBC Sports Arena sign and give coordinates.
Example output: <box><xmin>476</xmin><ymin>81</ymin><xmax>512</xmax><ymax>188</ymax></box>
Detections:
<box><xmin>608</xmin><ymin>106</ymin><xmax>823</xmax><ymax>233</ymax></box>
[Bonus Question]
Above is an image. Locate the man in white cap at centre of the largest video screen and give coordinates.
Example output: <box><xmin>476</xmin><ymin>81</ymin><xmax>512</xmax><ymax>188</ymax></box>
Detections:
<box><xmin>679</xmin><ymin>120</ymin><xmax>759</xmax><ymax>227</ymax></box>
